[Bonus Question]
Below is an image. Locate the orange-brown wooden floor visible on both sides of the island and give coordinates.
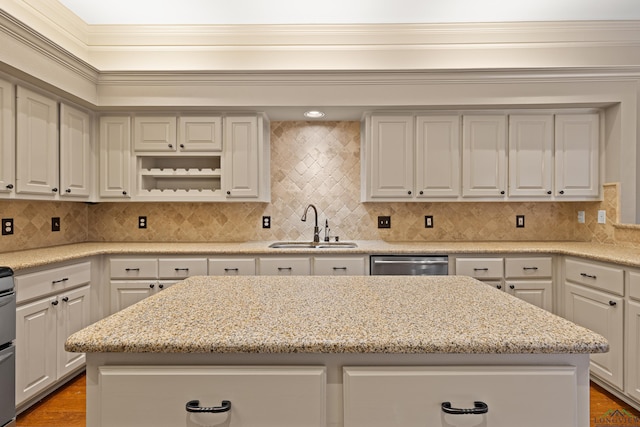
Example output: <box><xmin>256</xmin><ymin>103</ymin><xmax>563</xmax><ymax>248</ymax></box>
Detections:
<box><xmin>17</xmin><ymin>374</ymin><xmax>640</xmax><ymax>427</ymax></box>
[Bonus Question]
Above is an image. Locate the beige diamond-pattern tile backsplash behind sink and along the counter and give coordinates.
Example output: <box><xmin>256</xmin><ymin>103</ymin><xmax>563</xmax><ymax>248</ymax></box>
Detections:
<box><xmin>0</xmin><ymin>122</ymin><xmax>640</xmax><ymax>252</ymax></box>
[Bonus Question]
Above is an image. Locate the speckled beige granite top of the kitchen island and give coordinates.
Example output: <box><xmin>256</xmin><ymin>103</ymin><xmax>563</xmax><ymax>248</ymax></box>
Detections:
<box><xmin>66</xmin><ymin>276</ymin><xmax>608</xmax><ymax>354</ymax></box>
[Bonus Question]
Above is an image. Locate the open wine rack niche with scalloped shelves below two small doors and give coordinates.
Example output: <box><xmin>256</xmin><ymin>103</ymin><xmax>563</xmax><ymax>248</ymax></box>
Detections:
<box><xmin>137</xmin><ymin>154</ymin><xmax>223</xmax><ymax>200</ymax></box>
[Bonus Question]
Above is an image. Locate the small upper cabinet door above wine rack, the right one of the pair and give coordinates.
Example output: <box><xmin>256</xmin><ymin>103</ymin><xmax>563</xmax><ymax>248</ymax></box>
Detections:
<box><xmin>178</xmin><ymin>117</ymin><xmax>222</xmax><ymax>152</ymax></box>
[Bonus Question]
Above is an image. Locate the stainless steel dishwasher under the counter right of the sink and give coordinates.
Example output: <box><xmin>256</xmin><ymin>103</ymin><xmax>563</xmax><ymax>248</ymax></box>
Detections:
<box><xmin>369</xmin><ymin>255</ymin><xmax>449</xmax><ymax>276</ymax></box>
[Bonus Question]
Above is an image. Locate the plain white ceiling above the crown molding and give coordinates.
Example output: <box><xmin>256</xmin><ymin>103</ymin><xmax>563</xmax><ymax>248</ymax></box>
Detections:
<box><xmin>59</xmin><ymin>0</ymin><xmax>640</xmax><ymax>25</ymax></box>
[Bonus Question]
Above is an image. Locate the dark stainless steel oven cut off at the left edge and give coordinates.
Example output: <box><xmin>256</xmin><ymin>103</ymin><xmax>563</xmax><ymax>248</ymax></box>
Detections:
<box><xmin>0</xmin><ymin>267</ymin><xmax>16</xmax><ymax>427</ymax></box>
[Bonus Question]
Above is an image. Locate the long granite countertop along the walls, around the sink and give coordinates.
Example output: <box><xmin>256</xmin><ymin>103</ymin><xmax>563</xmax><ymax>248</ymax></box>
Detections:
<box><xmin>5</xmin><ymin>240</ymin><xmax>640</xmax><ymax>271</ymax></box>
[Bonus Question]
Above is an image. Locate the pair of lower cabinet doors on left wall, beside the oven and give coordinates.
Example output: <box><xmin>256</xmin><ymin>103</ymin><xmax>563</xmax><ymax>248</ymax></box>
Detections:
<box><xmin>16</xmin><ymin>285</ymin><xmax>90</xmax><ymax>405</ymax></box>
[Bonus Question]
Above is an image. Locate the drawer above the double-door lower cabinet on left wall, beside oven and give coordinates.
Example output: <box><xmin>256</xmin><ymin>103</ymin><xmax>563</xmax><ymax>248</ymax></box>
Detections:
<box><xmin>15</xmin><ymin>262</ymin><xmax>91</xmax><ymax>303</ymax></box>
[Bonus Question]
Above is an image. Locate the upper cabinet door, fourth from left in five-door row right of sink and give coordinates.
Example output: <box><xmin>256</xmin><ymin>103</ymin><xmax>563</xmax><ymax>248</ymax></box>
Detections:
<box><xmin>509</xmin><ymin>115</ymin><xmax>553</xmax><ymax>198</ymax></box>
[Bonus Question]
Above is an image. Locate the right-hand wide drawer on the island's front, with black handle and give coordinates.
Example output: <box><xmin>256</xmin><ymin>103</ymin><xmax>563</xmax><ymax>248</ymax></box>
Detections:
<box><xmin>344</xmin><ymin>366</ymin><xmax>578</xmax><ymax>427</ymax></box>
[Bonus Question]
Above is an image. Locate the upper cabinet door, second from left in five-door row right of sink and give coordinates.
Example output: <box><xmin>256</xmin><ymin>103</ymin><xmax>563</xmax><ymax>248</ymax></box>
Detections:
<box><xmin>416</xmin><ymin>116</ymin><xmax>460</xmax><ymax>198</ymax></box>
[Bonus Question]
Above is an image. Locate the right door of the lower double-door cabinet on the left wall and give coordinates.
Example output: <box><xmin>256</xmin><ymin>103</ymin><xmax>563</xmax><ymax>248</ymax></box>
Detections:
<box><xmin>56</xmin><ymin>286</ymin><xmax>91</xmax><ymax>378</ymax></box>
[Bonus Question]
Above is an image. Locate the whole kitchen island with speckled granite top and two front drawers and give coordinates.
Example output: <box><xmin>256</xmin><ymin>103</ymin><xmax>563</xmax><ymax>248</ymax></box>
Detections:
<box><xmin>66</xmin><ymin>276</ymin><xmax>608</xmax><ymax>427</ymax></box>
